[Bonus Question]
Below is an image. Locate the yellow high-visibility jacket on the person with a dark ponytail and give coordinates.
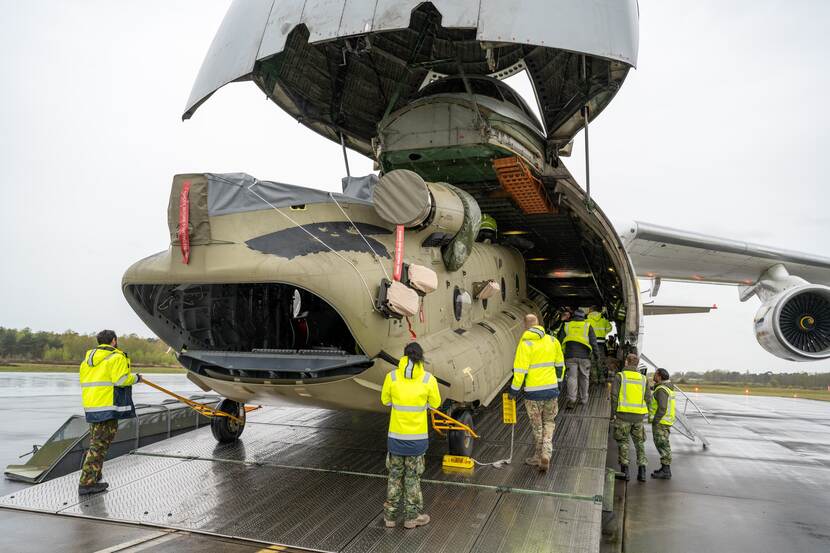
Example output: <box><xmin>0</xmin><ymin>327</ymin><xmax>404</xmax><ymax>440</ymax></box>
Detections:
<box><xmin>381</xmin><ymin>356</ymin><xmax>441</xmax><ymax>440</ymax></box>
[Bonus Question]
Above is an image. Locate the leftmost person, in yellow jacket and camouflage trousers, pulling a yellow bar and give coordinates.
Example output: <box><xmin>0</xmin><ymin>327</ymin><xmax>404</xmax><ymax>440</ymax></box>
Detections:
<box><xmin>78</xmin><ymin>330</ymin><xmax>141</xmax><ymax>495</ymax></box>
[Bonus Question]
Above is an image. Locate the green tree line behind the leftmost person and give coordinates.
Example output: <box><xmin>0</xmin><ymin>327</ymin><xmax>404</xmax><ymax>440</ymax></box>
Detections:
<box><xmin>0</xmin><ymin>327</ymin><xmax>178</xmax><ymax>365</ymax></box>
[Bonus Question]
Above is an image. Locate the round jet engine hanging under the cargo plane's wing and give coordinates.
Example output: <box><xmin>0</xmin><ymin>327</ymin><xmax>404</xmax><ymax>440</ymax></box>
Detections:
<box><xmin>755</xmin><ymin>284</ymin><xmax>830</xmax><ymax>361</ymax></box>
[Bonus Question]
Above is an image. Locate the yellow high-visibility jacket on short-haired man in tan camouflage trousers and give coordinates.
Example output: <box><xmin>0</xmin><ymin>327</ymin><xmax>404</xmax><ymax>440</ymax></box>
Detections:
<box><xmin>510</xmin><ymin>326</ymin><xmax>565</xmax><ymax>401</ymax></box>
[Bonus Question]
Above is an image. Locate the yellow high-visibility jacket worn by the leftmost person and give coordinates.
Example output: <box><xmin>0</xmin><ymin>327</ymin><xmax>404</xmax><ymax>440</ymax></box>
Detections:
<box><xmin>78</xmin><ymin>345</ymin><xmax>138</xmax><ymax>422</ymax></box>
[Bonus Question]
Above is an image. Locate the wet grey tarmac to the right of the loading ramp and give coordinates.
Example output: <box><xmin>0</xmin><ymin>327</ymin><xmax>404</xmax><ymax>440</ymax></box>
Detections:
<box><xmin>623</xmin><ymin>394</ymin><xmax>830</xmax><ymax>553</ymax></box>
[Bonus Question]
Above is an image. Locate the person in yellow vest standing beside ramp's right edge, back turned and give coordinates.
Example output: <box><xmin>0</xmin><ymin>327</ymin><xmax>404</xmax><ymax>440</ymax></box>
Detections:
<box><xmin>611</xmin><ymin>354</ymin><xmax>651</xmax><ymax>482</ymax></box>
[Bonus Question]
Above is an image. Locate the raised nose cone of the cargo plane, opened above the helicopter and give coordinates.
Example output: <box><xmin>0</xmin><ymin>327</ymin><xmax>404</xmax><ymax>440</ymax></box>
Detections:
<box><xmin>183</xmin><ymin>0</ymin><xmax>639</xmax><ymax>155</ymax></box>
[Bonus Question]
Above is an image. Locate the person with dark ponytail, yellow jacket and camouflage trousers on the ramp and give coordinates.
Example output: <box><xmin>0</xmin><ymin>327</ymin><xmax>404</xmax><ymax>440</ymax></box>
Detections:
<box><xmin>381</xmin><ymin>342</ymin><xmax>441</xmax><ymax>529</ymax></box>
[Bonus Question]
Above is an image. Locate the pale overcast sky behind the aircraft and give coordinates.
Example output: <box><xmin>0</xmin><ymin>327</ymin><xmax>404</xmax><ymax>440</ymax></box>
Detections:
<box><xmin>0</xmin><ymin>0</ymin><xmax>830</xmax><ymax>372</ymax></box>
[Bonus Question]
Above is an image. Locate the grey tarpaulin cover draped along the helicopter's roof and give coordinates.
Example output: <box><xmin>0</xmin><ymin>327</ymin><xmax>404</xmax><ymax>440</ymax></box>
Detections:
<box><xmin>205</xmin><ymin>173</ymin><xmax>371</xmax><ymax>217</ymax></box>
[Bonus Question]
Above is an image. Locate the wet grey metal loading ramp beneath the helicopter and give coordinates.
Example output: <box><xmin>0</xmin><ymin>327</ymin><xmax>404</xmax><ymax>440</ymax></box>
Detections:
<box><xmin>0</xmin><ymin>390</ymin><xmax>609</xmax><ymax>553</ymax></box>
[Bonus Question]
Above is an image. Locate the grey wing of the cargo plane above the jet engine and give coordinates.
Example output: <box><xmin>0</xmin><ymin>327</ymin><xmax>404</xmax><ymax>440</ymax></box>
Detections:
<box><xmin>619</xmin><ymin>222</ymin><xmax>830</xmax><ymax>286</ymax></box>
